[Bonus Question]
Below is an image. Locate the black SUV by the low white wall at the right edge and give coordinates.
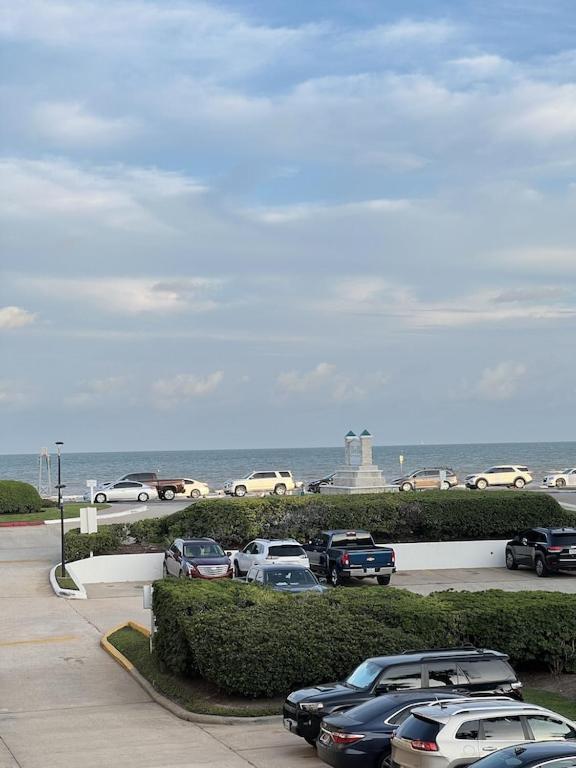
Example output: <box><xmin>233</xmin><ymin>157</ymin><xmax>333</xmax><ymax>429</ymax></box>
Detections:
<box><xmin>506</xmin><ymin>528</ymin><xmax>576</xmax><ymax>576</ymax></box>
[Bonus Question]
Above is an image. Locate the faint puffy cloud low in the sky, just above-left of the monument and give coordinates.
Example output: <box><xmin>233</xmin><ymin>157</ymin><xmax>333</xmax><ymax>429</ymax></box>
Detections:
<box><xmin>276</xmin><ymin>363</ymin><xmax>387</xmax><ymax>402</ymax></box>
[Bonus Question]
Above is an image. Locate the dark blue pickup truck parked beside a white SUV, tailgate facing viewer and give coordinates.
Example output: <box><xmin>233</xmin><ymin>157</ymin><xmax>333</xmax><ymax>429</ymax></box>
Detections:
<box><xmin>303</xmin><ymin>530</ymin><xmax>396</xmax><ymax>587</ymax></box>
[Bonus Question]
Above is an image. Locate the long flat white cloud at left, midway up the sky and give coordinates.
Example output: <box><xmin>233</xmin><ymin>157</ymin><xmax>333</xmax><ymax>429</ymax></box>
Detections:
<box><xmin>23</xmin><ymin>277</ymin><xmax>221</xmax><ymax>315</ymax></box>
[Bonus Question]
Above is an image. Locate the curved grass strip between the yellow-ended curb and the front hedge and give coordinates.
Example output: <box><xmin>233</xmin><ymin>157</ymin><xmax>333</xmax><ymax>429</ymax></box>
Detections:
<box><xmin>108</xmin><ymin>627</ymin><xmax>283</xmax><ymax>717</ymax></box>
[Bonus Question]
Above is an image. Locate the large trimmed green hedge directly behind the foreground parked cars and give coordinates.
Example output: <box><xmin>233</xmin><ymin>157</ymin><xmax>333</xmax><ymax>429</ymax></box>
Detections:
<box><xmin>154</xmin><ymin>580</ymin><xmax>576</xmax><ymax>697</ymax></box>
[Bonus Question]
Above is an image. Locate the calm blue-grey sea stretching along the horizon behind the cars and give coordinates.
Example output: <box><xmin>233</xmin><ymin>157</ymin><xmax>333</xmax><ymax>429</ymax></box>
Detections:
<box><xmin>0</xmin><ymin>442</ymin><xmax>576</xmax><ymax>494</ymax></box>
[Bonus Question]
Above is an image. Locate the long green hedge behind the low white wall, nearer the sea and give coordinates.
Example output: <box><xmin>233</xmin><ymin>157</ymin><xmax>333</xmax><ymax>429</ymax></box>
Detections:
<box><xmin>143</xmin><ymin>491</ymin><xmax>576</xmax><ymax>547</ymax></box>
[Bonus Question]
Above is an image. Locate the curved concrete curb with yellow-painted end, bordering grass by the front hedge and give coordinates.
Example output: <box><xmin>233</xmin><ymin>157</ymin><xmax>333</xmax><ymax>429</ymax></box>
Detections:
<box><xmin>100</xmin><ymin>621</ymin><xmax>282</xmax><ymax>725</ymax></box>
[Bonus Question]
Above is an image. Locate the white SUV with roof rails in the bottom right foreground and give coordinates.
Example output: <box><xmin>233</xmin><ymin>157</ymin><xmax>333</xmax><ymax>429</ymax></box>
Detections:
<box><xmin>392</xmin><ymin>697</ymin><xmax>576</xmax><ymax>768</ymax></box>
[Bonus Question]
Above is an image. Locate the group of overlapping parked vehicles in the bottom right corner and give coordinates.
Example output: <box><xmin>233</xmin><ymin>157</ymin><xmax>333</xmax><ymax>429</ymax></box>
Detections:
<box><xmin>283</xmin><ymin>646</ymin><xmax>576</xmax><ymax>768</ymax></box>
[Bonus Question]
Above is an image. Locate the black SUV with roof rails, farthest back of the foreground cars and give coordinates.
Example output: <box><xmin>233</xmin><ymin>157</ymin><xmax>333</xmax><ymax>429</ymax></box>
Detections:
<box><xmin>284</xmin><ymin>646</ymin><xmax>522</xmax><ymax>744</ymax></box>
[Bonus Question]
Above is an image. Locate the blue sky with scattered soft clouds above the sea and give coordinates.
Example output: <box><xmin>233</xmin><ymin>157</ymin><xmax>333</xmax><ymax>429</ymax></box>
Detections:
<box><xmin>0</xmin><ymin>0</ymin><xmax>576</xmax><ymax>453</ymax></box>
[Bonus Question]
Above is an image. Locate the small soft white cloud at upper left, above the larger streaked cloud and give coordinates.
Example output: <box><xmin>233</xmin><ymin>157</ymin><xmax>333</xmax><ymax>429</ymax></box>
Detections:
<box><xmin>33</xmin><ymin>101</ymin><xmax>138</xmax><ymax>147</ymax></box>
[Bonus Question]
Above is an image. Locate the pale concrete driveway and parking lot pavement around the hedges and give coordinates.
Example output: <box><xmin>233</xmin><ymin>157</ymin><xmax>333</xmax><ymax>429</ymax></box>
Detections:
<box><xmin>0</xmin><ymin>492</ymin><xmax>576</xmax><ymax>768</ymax></box>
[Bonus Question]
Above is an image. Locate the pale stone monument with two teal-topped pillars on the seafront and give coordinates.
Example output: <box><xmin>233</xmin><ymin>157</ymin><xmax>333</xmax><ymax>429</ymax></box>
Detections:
<box><xmin>320</xmin><ymin>429</ymin><xmax>387</xmax><ymax>494</ymax></box>
